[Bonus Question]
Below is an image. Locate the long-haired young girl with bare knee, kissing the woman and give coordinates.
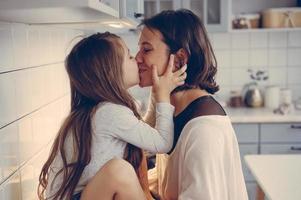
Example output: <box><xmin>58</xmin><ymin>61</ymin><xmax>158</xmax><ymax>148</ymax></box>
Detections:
<box><xmin>38</xmin><ymin>32</ymin><xmax>186</xmax><ymax>200</ymax></box>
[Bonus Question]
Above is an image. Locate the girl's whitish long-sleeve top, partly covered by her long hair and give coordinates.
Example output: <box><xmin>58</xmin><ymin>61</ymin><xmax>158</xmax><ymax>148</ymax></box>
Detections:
<box><xmin>46</xmin><ymin>102</ymin><xmax>174</xmax><ymax>197</ymax></box>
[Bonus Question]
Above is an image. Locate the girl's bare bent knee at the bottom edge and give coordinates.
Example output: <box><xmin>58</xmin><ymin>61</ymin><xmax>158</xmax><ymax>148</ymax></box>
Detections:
<box><xmin>81</xmin><ymin>159</ymin><xmax>146</xmax><ymax>200</ymax></box>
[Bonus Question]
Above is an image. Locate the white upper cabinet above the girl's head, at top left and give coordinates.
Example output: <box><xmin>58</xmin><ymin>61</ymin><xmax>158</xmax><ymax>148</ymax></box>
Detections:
<box><xmin>0</xmin><ymin>0</ymin><xmax>144</xmax><ymax>30</ymax></box>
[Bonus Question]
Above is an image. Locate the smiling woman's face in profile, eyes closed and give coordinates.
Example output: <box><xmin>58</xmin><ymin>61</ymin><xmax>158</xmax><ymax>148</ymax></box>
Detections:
<box><xmin>136</xmin><ymin>27</ymin><xmax>169</xmax><ymax>87</ymax></box>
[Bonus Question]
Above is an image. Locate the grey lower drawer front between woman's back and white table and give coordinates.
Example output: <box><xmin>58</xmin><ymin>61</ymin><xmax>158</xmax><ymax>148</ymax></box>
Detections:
<box><xmin>239</xmin><ymin>144</ymin><xmax>258</xmax><ymax>181</ymax></box>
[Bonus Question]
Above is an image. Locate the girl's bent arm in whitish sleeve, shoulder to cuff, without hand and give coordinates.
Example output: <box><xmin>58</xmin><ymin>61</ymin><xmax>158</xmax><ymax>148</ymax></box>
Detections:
<box><xmin>95</xmin><ymin>103</ymin><xmax>174</xmax><ymax>153</ymax></box>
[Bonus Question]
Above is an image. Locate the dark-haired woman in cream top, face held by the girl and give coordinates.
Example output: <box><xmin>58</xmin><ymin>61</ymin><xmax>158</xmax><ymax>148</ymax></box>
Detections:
<box><xmin>136</xmin><ymin>9</ymin><xmax>248</xmax><ymax>200</ymax></box>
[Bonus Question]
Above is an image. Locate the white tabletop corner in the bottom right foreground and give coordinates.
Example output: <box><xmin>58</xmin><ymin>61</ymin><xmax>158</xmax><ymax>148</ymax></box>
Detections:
<box><xmin>245</xmin><ymin>155</ymin><xmax>301</xmax><ymax>200</ymax></box>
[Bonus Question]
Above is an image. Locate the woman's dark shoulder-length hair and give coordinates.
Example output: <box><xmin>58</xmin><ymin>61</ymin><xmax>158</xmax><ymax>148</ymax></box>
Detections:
<box><xmin>140</xmin><ymin>9</ymin><xmax>219</xmax><ymax>94</ymax></box>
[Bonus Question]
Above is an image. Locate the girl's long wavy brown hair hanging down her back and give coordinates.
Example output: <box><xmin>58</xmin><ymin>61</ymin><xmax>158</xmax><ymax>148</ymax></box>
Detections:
<box><xmin>38</xmin><ymin>32</ymin><xmax>143</xmax><ymax>199</ymax></box>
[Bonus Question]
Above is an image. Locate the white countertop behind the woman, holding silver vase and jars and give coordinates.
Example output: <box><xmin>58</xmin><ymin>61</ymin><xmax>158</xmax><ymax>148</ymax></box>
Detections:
<box><xmin>224</xmin><ymin>107</ymin><xmax>301</xmax><ymax>123</ymax></box>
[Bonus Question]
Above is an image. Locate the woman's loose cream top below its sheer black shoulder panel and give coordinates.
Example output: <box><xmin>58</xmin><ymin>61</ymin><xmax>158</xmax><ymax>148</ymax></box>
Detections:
<box><xmin>161</xmin><ymin>115</ymin><xmax>248</xmax><ymax>200</ymax></box>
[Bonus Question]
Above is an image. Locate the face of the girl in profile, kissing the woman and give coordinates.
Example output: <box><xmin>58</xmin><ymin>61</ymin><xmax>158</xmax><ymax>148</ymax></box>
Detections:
<box><xmin>121</xmin><ymin>41</ymin><xmax>139</xmax><ymax>89</ymax></box>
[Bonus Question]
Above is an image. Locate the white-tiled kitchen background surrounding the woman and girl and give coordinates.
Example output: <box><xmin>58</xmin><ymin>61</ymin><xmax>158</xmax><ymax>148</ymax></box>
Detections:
<box><xmin>0</xmin><ymin>0</ymin><xmax>301</xmax><ymax>200</ymax></box>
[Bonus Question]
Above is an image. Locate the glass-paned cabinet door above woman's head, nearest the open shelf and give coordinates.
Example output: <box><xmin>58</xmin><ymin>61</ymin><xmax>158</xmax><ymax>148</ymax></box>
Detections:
<box><xmin>182</xmin><ymin>0</ymin><xmax>230</xmax><ymax>32</ymax></box>
